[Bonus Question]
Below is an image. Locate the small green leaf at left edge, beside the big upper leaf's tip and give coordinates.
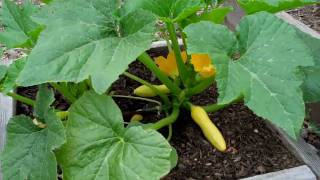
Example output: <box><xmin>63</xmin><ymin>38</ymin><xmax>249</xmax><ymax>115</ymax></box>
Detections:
<box><xmin>0</xmin><ymin>57</ymin><xmax>27</xmax><ymax>93</ymax></box>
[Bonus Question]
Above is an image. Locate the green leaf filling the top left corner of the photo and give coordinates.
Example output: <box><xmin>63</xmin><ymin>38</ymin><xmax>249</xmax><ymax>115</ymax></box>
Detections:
<box><xmin>0</xmin><ymin>0</ymin><xmax>42</xmax><ymax>48</ymax></box>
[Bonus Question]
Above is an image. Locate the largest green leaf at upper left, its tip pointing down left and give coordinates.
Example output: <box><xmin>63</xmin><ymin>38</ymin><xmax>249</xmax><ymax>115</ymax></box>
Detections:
<box><xmin>18</xmin><ymin>0</ymin><xmax>155</xmax><ymax>93</ymax></box>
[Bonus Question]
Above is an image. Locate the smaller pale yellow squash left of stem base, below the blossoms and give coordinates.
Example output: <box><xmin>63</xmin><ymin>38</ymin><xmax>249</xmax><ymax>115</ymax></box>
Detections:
<box><xmin>133</xmin><ymin>85</ymin><xmax>170</xmax><ymax>97</ymax></box>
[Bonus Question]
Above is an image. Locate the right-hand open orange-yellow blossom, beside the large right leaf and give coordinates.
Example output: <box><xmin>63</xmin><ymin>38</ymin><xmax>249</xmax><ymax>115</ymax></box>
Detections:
<box><xmin>191</xmin><ymin>54</ymin><xmax>216</xmax><ymax>78</ymax></box>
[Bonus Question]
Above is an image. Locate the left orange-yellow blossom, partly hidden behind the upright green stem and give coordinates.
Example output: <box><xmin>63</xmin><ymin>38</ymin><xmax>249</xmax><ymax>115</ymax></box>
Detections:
<box><xmin>155</xmin><ymin>51</ymin><xmax>187</xmax><ymax>78</ymax></box>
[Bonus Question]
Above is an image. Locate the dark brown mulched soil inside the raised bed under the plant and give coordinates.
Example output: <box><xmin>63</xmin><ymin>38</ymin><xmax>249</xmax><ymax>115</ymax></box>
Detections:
<box><xmin>17</xmin><ymin>49</ymin><xmax>302</xmax><ymax>180</ymax></box>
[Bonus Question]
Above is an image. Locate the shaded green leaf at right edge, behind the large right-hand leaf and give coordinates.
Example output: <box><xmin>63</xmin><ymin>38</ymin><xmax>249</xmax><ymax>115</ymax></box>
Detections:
<box><xmin>297</xmin><ymin>30</ymin><xmax>320</xmax><ymax>103</ymax></box>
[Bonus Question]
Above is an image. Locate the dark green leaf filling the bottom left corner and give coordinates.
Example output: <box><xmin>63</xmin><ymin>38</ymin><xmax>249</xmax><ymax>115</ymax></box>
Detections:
<box><xmin>1</xmin><ymin>88</ymin><xmax>65</xmax><ymax>180</ymax></box>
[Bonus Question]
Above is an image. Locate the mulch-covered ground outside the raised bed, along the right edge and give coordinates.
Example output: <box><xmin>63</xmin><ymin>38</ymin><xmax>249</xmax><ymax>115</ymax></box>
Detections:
<box><xmin>288</xmin><ymin>5</ymin><xmax>320</xmax><ymax>156</ymax></box>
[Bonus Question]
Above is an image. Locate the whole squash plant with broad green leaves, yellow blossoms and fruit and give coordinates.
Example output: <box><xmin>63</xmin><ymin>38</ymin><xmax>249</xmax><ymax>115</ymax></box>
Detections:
<box><xmin>0</xmin><ymin>0</ymin><xmax>320</xmax><ymax>180</ymax></box>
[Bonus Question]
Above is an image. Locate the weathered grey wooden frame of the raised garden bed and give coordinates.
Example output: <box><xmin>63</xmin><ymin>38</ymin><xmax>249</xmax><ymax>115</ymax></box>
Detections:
<box><xmin>0</xmin><ymin>0</ymin><xmax>320</xmax><ymax>180</ymax></box>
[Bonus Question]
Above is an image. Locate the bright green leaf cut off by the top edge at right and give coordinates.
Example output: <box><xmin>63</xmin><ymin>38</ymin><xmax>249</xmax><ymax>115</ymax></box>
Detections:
<box><xmin>237</xmin><ymin>0</ymin><xmax>319</xmax><ymax>14</ymax></box>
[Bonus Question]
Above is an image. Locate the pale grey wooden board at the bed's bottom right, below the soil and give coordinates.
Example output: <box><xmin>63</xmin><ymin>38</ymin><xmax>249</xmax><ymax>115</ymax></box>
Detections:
<box><xmin>242</xmin><ymin>165</ymin><xmax>316</xmax><ymax>180</ymax></box>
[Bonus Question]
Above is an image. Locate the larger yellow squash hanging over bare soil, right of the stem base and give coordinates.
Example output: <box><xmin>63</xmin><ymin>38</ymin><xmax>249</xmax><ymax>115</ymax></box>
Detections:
<box><xmin>191</xmin><ymin>106</ymin><xmax>227</xmax><ymax>152</ymax></box>
